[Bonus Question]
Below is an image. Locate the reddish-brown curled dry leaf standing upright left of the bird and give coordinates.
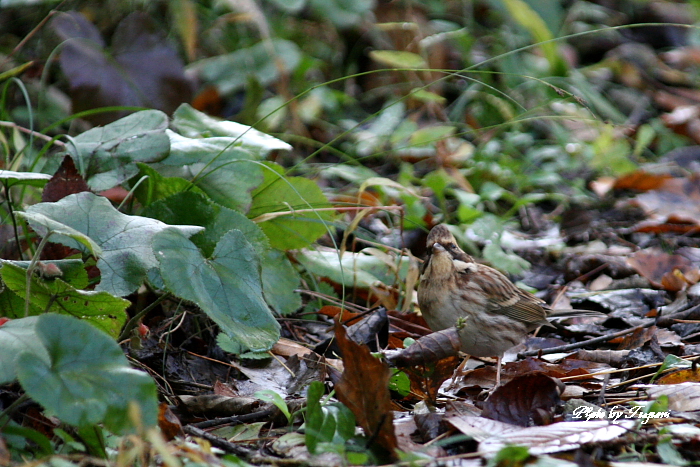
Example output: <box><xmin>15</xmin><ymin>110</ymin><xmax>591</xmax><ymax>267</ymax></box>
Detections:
<box><xmin>335</xmin><ymin>321</ymin><xmax>397</xmax><ymax>460</ymax></box>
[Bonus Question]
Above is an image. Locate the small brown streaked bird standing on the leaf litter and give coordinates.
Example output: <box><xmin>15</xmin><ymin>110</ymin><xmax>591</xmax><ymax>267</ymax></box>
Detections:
<box><xmin>418</xmin><ymin>225</ymin><xmax>600</xmax><ymax>386</ymax></box>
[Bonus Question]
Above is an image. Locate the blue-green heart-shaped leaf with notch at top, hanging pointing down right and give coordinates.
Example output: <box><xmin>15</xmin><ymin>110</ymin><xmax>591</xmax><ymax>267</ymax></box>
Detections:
<box><xmin>153</xmin><ymin>229</ymin><xmax>279</xmax><ymax>351</ymax></box>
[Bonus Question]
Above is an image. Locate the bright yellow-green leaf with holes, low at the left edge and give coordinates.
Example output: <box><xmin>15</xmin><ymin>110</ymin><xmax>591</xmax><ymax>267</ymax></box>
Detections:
<box><xmin>0</xmin><ymin>261</ymin><xmax>131</xmax><ymax>339</ymax></box>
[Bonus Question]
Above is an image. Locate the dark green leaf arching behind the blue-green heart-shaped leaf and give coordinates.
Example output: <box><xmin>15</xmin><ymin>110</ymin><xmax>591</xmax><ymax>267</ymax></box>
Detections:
<box><xmin>143</xmin><ymin>192</ymin><xmax>301</xmax><ymax>314</ymax></box>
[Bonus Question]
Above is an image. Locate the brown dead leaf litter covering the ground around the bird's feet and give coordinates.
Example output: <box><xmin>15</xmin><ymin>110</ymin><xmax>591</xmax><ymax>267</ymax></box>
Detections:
<box><xmin>121</xmin><ymin>171</ymin><xmax>700</xmax><ymax>465</ymax></box>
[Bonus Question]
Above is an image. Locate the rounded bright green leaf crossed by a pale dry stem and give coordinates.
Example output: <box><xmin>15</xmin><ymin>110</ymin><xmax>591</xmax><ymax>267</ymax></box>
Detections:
<box><xmin>248</xmin><ymin>165</ymin><xmax>332</xmax><ymax>250</ymax></box>
